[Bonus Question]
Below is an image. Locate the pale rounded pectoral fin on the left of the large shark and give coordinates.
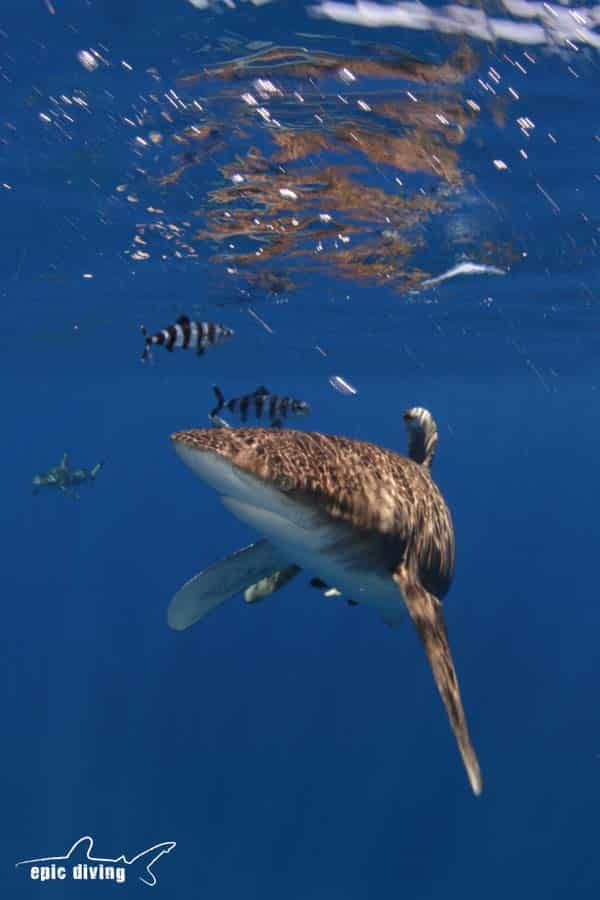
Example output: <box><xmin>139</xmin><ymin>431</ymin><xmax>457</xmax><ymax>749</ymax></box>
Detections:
<box><xmin>167</xmin><ymin>540</ymin><xmax>290</xmax><ymax>631</ymax></box>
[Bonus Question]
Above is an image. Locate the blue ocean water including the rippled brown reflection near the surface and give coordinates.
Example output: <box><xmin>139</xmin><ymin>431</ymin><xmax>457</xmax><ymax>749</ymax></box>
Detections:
<box><xmin>0</xmin><ymin>0</ymin><xmax>600</xmax><ymax>900</ymax></box>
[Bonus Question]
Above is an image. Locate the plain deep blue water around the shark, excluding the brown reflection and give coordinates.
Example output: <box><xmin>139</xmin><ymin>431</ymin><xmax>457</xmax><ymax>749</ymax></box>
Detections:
<box><xmin>0</xmin><ymin>0</ymin><xmax>600</xmax><ymax>900</ymax></box>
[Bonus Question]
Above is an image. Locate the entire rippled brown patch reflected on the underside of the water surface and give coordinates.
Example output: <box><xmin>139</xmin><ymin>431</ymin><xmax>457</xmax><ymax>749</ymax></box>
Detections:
<box><xmin>131</xmin><ymin>44</ymin><xmax>516</xmax><ymax>296</ymax></box>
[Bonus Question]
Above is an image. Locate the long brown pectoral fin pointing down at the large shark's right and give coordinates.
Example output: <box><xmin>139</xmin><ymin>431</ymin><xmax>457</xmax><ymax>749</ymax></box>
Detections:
<box><xmin>394</xmin><ymin>566</ymin><xmax>482</xmax><ymax>794</ymax></box>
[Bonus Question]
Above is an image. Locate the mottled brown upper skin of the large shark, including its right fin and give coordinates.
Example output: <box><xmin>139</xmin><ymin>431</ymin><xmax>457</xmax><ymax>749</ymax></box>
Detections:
<box><xmin>172</xmin><ymin>428</ymin><xmax>482</xmax><ymax>794</ymax></box>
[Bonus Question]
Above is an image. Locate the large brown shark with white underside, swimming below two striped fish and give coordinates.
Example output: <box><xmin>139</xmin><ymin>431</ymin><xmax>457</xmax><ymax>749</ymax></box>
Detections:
<box><xmin>168</xmin><ymin>407</ymin><xmax>482</xmax><ymax>794</ymax></box>
